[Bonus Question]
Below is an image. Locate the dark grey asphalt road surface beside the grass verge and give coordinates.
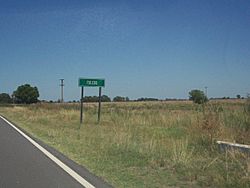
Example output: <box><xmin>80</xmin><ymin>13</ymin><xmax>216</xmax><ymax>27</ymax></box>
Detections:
<box><xmin>0</xmin><ymin>117</ymin><xmax>110</xmax><ymax>188</ymax></box>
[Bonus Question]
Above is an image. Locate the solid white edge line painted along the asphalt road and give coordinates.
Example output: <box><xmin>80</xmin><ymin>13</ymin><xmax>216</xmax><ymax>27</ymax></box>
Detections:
<box><xmin>0</xmin><ymin>116</ymin><xmax>94</xmax><ymax>188</ymax></box>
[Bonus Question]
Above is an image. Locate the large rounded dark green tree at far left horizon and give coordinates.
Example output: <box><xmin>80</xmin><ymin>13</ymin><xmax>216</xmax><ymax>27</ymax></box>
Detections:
<box><xmin>13</xmin><ymin>84</ymin><xmax>39</xmax><ymax>104</ymax></box>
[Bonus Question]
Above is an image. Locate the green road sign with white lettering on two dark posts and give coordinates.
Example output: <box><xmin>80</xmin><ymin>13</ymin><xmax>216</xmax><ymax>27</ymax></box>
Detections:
<box><xmin>78</xmin><ymin>78</ymin><xmax>105</xmax><ymax>124</ymax></box>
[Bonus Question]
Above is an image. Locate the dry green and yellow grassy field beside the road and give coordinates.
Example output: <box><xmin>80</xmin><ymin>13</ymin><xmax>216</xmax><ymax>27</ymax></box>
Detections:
<box><xmin>0</xmin><ymin>100</ymin><xmax>250</xmax><ymax>187</ymax></box>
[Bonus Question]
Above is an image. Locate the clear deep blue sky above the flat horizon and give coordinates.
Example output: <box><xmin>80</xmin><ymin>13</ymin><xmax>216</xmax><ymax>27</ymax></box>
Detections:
<box><xmin>0</xmin><ymin>0</ymin><xmax>250</xmax><ymax>100</ymax></box>
